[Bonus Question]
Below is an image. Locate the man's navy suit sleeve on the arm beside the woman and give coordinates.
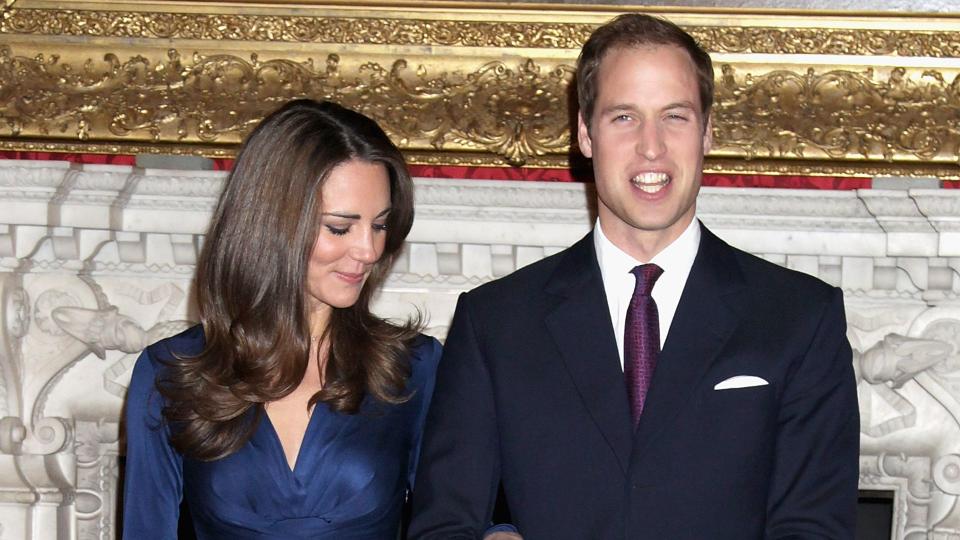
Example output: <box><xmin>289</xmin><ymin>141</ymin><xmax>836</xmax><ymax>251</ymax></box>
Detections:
<box><xmin>409</xmin><ymin>295</ymin><xmax>500</xmax><ymax>540</ymax></box>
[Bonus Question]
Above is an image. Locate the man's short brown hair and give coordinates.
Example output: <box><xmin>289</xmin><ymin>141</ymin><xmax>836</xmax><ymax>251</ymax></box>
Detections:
<box><xmin>577</xmin><ymin>13</ymin><xmax>713</xmax><ymax>126</ymax></box>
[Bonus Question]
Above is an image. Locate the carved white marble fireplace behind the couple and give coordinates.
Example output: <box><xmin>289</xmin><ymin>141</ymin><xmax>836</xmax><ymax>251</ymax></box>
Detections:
<box><xmin>0</xmin><ymin>161</ymin><xmax>960</xmax><ymax>540</ymax></box>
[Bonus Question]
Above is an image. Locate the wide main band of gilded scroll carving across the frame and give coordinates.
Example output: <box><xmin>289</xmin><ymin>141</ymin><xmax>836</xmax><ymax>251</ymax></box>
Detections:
<box><xmin>0</xmin><ymin>43</ymin><xmax>960</xmax><ymax>165</ymax></box>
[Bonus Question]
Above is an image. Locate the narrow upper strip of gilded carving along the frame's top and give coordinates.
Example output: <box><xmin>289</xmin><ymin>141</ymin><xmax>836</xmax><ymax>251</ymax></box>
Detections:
<box><xmin>0</xmin><ymin>9</ymin><xmax>960</xmax><ymax>58</ymax></box>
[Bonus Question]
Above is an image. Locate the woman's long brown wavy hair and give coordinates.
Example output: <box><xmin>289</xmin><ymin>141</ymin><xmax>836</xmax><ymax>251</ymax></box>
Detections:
<box><xmin>157</xmin><ymin>100</ymin><xmax>420</xmax><ymax>460</ymax></box>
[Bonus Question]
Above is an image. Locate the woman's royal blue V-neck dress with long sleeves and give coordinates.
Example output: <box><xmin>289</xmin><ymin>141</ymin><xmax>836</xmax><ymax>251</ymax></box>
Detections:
<box><xmin>123</xmin><ymin>326</ymin><xmax>440</xmax><ymax>540</ymax></box>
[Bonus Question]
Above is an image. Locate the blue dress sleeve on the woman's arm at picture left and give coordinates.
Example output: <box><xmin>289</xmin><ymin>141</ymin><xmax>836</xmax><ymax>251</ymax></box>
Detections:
<box><xmin>123</xmin><ymin>349</ymin><xmax>183</xmax><ymax>540</ymax></box>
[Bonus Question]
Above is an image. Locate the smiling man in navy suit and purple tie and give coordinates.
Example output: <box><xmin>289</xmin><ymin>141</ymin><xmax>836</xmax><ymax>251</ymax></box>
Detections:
<box><xmin>411</xmin><ymin>15</ymin><xmax>859</xmax><ymax>540</ymax></box>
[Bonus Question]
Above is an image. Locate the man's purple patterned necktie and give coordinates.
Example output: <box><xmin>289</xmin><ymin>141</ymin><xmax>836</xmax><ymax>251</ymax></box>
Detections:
<box><xmin>623</xmin><ymin>264</ymin><xmax>663</xmax><ymax>429</ymax></box>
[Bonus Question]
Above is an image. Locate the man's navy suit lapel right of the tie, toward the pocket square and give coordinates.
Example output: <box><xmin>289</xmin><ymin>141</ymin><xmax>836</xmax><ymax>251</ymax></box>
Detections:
<box><xmin>633</xmin><ymin>225</ymin><xmax>744</xmax><ymax>460</ymax></box>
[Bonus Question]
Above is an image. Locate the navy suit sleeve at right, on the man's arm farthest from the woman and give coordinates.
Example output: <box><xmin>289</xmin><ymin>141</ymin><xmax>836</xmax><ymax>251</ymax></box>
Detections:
<box><xmin>766</xmin><ymin>289</ymin><xmax>860</xmax><ymax>539</ymax></box>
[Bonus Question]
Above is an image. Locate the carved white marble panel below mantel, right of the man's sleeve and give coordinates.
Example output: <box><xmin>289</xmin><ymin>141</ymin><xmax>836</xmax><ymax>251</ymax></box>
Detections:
<box><xmin>847</xmin><ymin>308</ymin><xmax>960</xmax><ymax>539</ymax></box>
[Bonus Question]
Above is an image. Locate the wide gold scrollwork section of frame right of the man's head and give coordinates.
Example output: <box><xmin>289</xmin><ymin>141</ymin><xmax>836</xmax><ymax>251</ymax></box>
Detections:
<box><xmin>714</xmin><ymin>64</ymin><xmax>960</xmax><ymax>162</ymax></box>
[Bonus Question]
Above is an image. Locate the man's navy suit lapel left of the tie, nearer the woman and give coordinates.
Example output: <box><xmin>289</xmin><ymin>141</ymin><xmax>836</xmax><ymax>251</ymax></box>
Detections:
<box><xmin>546</xmin><ymin>234</ymin><xmax>632</xmax><ymax>472</ymax></box>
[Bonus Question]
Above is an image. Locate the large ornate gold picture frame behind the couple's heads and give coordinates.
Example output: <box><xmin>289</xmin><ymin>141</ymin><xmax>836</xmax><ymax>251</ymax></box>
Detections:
<box><xmin>0</xmin><ymin>0</ymin><xmax>960</xmax><ymax>179</ymax></box>
